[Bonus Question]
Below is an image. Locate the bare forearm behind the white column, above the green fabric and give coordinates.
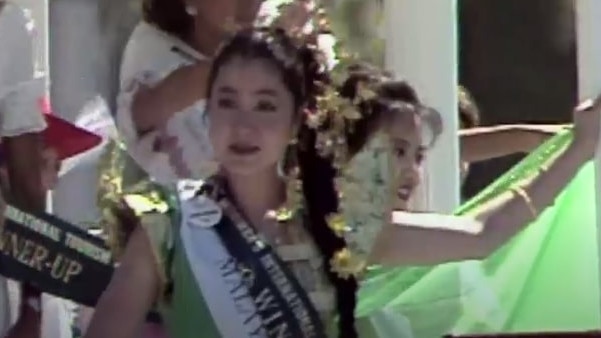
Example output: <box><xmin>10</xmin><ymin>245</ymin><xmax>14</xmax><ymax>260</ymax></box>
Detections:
<box><xmin>459</xmin><ymin>124</ymin><xmax>566</xmax><ymax>162</ymax></box>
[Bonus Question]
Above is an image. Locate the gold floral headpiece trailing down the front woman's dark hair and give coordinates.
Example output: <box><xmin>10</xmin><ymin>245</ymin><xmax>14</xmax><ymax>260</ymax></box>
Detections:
<box><xmin>268</xmin><ymin>3</ymin><xmax>377</xmax><ymax>278</ymax></box>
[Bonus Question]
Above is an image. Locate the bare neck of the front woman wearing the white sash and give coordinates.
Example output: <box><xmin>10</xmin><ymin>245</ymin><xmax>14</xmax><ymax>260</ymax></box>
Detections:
<box><xmin>226</xmin><ymin>170</ymin><xmax>286</xmax><ymax>227</ymax></box>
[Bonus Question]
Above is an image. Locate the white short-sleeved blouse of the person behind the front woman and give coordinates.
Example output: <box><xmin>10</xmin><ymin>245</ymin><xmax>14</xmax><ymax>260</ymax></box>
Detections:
<box><xmin>116</xmin><ymin>22</ymin><xmax>212</xmax><ymax>184</ymax></box>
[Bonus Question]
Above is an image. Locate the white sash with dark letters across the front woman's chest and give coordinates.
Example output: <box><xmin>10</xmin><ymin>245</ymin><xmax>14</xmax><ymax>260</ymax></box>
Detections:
<box><xmin>180</xmin><ymin>184</ymin><xmax>266</xmax><ymax>338</ymax></box>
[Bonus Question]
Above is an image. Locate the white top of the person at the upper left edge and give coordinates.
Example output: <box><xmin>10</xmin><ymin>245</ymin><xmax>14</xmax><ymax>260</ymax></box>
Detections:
<box><xmin>0</xmin><ymin>2</ymin><xmax>46</xmax><ymax>137</ymax></box>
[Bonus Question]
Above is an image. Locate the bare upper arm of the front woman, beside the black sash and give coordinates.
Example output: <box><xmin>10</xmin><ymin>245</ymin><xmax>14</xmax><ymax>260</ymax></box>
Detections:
<box><xmin>84</xmin><ymin>227</ymin><xmax>160</xmax><ymax>338</ymax></box>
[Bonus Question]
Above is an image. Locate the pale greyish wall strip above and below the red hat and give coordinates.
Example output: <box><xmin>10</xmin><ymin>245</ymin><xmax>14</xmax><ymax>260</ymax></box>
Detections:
<box><xmin>48</xmin><ymin>0</ymin><xmax>99</xmax><ymax>222</ymax></box>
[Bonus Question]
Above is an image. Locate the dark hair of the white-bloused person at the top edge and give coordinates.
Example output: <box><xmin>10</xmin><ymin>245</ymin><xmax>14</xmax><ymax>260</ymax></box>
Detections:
<box><xmin>142</xmin><ymin>0</ymin><xmax>194</xmax><ymax>41</ymax></box>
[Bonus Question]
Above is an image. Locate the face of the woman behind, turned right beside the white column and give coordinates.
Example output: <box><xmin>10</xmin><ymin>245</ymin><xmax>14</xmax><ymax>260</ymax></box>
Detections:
<box><xmin>388</xmin><ymin>113</ymin><xmax>426</xmax><ymax>210</ymax></box>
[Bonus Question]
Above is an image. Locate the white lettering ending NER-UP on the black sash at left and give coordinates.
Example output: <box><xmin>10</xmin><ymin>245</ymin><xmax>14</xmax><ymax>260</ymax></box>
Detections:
<box><xmin>0</xmin><ymin>205</ymin><xmax>111</xmax><ymax>284</ymax></box>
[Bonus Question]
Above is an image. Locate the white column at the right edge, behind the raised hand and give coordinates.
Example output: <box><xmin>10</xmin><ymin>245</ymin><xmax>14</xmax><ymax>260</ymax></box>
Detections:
<box><xmin>574</xmin><ymin>0</ymin><xmax>601</xmax><ymax>316</ymax></box>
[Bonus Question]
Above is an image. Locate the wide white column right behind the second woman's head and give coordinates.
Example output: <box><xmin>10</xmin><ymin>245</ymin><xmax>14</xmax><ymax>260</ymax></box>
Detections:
<box><xmin>385</xmin><ymin>0</ymin><xmax>460</xmax><ymax>212</ymax></box>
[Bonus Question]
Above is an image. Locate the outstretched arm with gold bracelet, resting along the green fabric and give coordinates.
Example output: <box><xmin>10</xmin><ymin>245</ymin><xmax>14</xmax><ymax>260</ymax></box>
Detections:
<box><xmin>372</xmin><ymin>98</ymin><xmax>601</xmax><ymax>265</ymax></box>
